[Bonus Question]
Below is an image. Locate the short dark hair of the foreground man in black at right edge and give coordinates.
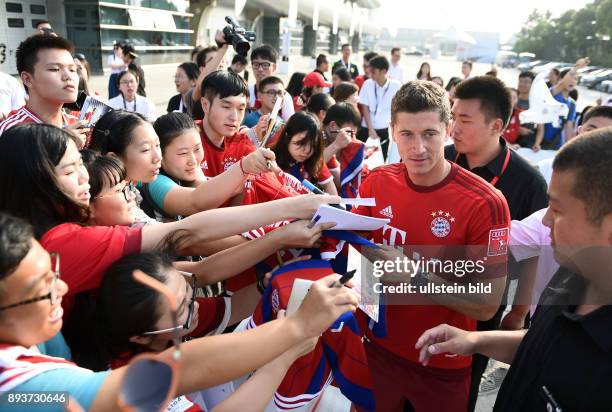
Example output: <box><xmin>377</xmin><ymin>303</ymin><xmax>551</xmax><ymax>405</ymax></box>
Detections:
<box><xmin>553</xmin><ymin>127</ymin><xmax>612</xmax><ymax>226</ymax></box>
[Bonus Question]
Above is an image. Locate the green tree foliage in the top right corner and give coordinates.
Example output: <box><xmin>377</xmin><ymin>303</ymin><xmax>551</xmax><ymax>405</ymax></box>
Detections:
<box><xmin>514</xmin><ymin>0</ymin><xmax>612</xmax><ymax>67</ymax></box>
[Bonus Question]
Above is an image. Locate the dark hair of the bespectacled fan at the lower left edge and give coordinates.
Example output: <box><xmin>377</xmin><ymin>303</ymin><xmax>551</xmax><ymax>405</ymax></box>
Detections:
<box><xmin>0</xmin><ymin>212</ymin><xmax>34</xmax><ymax>281</ymax></box>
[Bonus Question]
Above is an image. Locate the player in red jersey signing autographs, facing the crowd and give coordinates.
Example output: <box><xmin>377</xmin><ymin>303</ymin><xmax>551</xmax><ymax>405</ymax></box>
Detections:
<box><xmin>353</xmin><ymin>81</ymin><xmax>510</xmax><ymax>412</ymax></box>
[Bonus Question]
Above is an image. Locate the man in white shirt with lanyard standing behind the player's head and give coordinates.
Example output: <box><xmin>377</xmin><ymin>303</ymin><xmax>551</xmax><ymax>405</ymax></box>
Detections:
<box><xmin>357</xmin><ymin>56</ymin><xmax>402</xmax><ymax>159</ymax></box>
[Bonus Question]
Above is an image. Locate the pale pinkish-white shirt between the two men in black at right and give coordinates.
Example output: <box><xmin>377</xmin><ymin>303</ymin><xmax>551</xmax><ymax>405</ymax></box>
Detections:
<box><xmin>510</xmin><ymin>208</ymin><xmax>559</xmax><ymax>315</ymax></box>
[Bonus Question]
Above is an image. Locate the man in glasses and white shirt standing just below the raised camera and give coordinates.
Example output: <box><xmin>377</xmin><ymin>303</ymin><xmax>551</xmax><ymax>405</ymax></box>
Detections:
<box><xmin>249</xmin><ymin>44</ymin><xmax>295</xmax><ymax>122</ymax></box>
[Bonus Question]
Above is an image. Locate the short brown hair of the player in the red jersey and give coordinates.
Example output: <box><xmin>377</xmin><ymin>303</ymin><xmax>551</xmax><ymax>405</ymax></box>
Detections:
<box><xmin>391</xmin><ymin>80</ymin><xmax>450</xmax><ymax>125</ymax></box>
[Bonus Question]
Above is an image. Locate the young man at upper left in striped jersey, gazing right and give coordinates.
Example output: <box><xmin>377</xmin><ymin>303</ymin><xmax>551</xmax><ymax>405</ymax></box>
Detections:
<box><xmin>0</xmin><ymin>35</ymin><xmax>87</xmax><ymax>147</ymax></box>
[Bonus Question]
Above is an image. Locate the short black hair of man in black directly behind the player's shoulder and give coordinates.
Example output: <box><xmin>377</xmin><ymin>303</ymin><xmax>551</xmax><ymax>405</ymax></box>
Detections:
<box><xmin>455</xmin><ymin>76</ymin><xmax>512</xmax><ymax>127</ymax></box>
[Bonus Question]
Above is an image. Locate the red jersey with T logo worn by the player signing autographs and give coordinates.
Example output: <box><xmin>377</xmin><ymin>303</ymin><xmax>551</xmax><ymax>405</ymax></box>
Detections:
<box><xmin>352</xmin><ymin>163</ymin><xmax>510</xmax><ymax>369</ymax></box>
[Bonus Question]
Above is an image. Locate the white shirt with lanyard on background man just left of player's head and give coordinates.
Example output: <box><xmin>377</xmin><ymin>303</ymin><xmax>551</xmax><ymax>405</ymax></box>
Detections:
<box><xmin>359</xmin><ymin>79</ymin><xmax>402</xmax><ymax>130</ymax></box>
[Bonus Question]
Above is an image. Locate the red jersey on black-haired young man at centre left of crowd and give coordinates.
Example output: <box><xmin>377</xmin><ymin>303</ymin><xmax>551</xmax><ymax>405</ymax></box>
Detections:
<box><xmin>196</xmin><ymin>121</ymin><xmax>257</xmax><ymax>177</ymax></box>
